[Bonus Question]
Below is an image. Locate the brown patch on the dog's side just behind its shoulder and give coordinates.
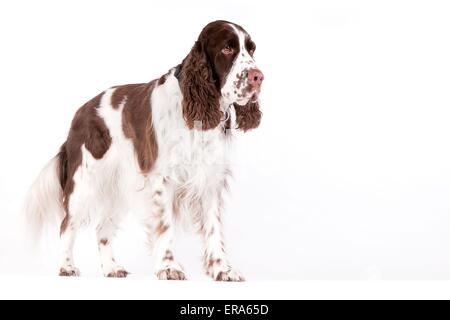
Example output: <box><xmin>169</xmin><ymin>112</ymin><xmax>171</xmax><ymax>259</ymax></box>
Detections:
<box><xmin>115</xmin><ymin>81</ymin><xmax>158</xmax><ymax>173</ymax></box>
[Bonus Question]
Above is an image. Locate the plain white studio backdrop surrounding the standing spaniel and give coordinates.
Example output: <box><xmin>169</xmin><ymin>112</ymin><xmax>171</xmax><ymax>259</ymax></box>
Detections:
<box><xmin>0</xmin><ymin>0</ymin><xmax>450</xmax><ymax>296</ymax></box>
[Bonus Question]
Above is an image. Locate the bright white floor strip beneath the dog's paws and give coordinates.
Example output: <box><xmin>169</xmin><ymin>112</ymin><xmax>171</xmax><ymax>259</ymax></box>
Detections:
<box><xmin>0</xmin><ymin>275</ymin><xmax>450</xmax><ymax>300</ymax></box>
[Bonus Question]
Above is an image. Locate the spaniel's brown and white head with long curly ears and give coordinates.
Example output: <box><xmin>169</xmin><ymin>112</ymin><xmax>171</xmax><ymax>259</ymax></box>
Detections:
<box><xmin>180</xmin><ymin>21</ymin><xmax>264</xmax><ymax>130</ymax></box>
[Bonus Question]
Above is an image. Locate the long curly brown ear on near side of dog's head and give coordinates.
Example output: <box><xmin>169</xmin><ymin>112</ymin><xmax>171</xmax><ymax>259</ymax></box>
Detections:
<box><xmin>180</xmin><ymin>41</ymin><xmax>223</xmax><ymax>130</ymax></box>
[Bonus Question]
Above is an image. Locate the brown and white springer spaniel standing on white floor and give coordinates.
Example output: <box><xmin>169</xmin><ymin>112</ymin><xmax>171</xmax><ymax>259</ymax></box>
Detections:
<box><xmin>25</xmin><ymin>21</ymin><xmax>263</xmax><ymax>281</ymax></box>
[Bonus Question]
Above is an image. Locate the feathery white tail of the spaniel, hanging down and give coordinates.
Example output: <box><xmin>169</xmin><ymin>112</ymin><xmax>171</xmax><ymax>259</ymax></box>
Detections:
<box><xmin>23</xmin><ymin>145</ymin><xmax>67</xmax><ymax>244</ymax></box>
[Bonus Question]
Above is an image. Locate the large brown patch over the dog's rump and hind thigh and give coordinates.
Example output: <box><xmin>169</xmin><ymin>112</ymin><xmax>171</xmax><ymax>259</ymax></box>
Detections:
<box><xmin>58</xmin><ymin>93</ymin><xmax>111</xmax><ymax>225</ymax></box>
